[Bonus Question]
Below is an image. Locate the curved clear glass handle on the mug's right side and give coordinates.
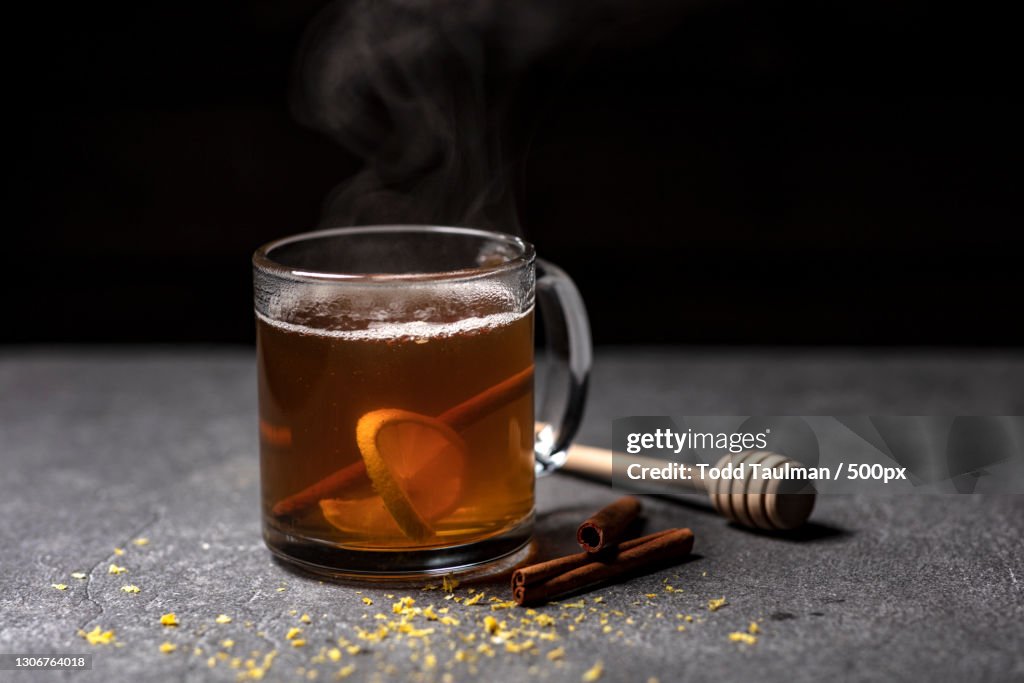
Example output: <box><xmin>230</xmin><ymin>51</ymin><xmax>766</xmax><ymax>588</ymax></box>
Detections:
<box><xmin>534</xmin><ymin>259</ymin><xmax>593</xmax><ymax>476</ymax></box>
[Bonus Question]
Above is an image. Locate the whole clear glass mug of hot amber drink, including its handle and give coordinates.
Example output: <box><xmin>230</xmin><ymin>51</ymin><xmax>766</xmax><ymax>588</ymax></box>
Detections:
<box><xmin>253</xmin><ymin>225</ymin><xmax>591</xmax><ymax>579</ymax></box>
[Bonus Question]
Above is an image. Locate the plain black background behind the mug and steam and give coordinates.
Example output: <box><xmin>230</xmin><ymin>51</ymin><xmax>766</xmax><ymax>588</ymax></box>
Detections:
<box><xmin>9</xmin><ymin>0</ymin><xmax>1024</xmax><ymax>346</ymax></box>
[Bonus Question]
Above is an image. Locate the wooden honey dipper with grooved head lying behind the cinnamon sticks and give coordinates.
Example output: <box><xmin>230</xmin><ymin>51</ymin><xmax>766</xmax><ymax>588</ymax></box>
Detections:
<box><xmin>565</xmin><ymin>444</ymin><xmax>815</xmax><ymax>531</ymax></box>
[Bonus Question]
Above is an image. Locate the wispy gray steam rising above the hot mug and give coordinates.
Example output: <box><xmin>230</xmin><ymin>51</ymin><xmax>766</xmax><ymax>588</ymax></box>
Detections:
<box><xmin>293</xmin><ymin>0</ymin><xmax>679</xmax><ymax>231</ymax></box>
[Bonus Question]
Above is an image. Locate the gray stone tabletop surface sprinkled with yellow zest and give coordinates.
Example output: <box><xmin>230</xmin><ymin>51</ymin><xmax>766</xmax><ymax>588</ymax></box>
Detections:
<box><xmin>0</xmin><ymin>349</ymin><xmax>1024</xmax><ymax>683</ymax></box>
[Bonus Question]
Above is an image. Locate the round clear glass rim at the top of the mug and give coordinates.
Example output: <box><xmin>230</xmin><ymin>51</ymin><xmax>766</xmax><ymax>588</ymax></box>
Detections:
<box><xmin>252</xmin><ymin>223</ymin><xmax>536</xmax><ymax>284</ymax></box>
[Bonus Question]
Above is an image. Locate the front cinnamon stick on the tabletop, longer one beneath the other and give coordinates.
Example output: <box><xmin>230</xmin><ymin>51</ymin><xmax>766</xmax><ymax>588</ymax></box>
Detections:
<box><xmin>512</xmin><ymin>528</ymin><xmax>693</xmax><ymax>605</ymax></box>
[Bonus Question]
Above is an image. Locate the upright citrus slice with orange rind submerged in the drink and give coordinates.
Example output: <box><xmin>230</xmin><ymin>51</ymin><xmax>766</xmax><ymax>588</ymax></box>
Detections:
<box><xmin>355</xmin><ymin>409</ymin><xmax>466</xmax><ymax>541</ymax></box>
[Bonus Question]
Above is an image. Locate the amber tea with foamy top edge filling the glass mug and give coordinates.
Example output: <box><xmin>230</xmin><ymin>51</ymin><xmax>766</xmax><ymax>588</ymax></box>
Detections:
<box><xmin>257</xmin><ymin>311</ymin><xmax>534</xmax><ymax>550</ymax></box>
